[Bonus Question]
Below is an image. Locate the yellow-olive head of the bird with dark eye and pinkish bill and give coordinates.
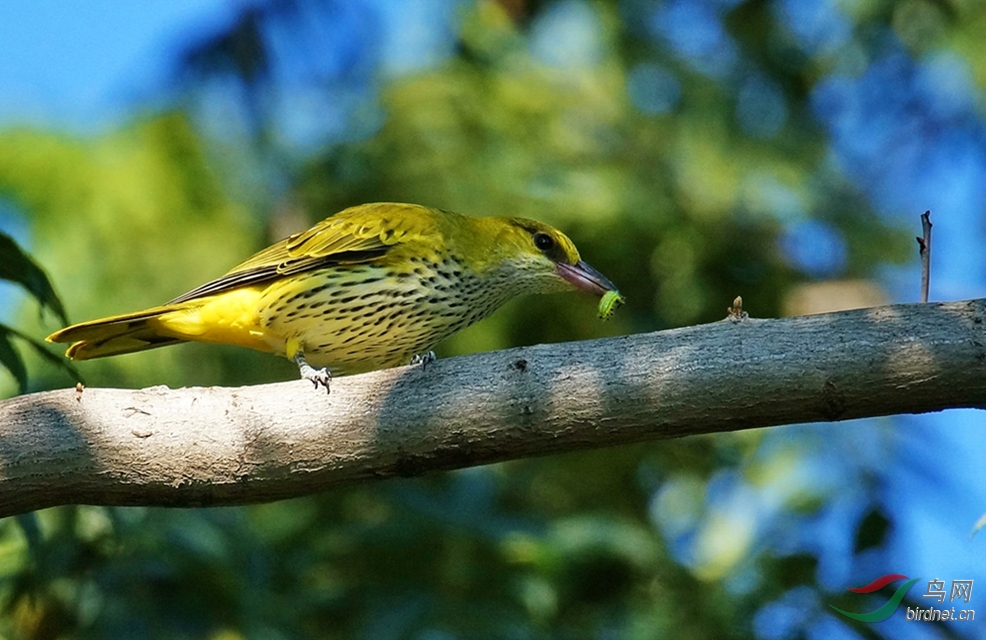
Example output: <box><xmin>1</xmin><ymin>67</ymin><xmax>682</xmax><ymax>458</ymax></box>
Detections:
<box><xmin>487</xmin><ymin>218</ymin><xmax>616</xmax><ymax>296</ymax></box>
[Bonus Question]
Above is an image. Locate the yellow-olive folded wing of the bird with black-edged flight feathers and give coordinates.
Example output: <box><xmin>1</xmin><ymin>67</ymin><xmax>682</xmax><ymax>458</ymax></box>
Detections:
<box><xmin>168</xmin><ymin>203</ymin><xmax>433</xmax><ymax>304</ymax></box>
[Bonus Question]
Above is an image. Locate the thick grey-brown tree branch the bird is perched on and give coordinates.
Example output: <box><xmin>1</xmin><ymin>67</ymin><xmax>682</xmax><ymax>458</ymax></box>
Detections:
<box><xmin>0</xmin><ymin>300</ymin><xmax>986</xmax><ymax>516</ymax></box>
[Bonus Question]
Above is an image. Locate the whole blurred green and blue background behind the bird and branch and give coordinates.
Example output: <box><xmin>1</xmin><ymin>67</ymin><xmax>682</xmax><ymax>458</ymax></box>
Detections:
<box><xmin>0</xmin><ymin>0</ymin><xmax>986</xmax><ymax>640</ymax></box>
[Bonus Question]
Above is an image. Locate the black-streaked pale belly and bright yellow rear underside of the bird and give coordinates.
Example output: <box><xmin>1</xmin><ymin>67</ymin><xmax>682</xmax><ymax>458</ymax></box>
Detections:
<box><xmin>156</xmin><ymin>265</ymin><xmax>509</xmax><ymax>374</ymax></box>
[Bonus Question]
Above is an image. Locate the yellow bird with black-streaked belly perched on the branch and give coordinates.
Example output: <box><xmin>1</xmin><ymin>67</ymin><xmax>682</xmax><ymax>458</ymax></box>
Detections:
<box><xmin>47</xmin><ymin>202</ymin><xmax>618</xmax><ymax>391</ymax></box>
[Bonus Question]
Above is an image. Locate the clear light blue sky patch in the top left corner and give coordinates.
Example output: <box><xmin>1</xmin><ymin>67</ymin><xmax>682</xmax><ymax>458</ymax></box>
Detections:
<box><xmin>0</xmin><ymin>0</ymin><xmax>236</xmax><ymax>131</ymax></box>
